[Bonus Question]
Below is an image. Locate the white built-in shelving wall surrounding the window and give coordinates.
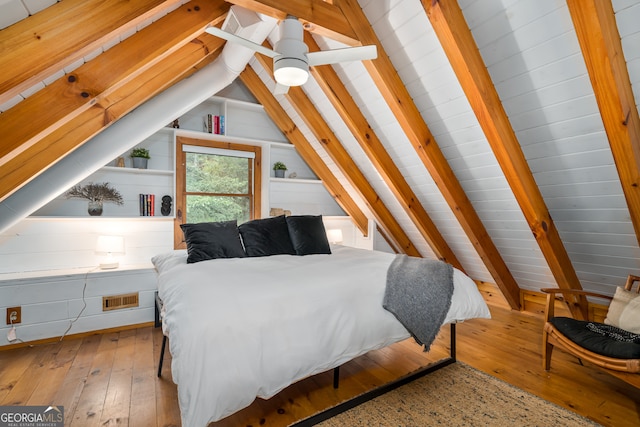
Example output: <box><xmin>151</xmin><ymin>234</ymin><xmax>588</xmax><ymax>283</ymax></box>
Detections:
<box><xmin>32</xmin><ymin>96</ymin><xmax>345</xmax><ymax>219</ymax></box>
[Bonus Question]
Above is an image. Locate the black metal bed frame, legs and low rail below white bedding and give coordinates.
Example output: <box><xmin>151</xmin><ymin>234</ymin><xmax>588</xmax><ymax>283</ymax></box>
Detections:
<box><xmin>154</xmin><ymin>291</ymin><xmax>456</xmax><ymax>427</ymax></box>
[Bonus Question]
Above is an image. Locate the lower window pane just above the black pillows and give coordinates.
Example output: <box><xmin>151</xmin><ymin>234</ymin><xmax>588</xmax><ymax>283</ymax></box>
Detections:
<box><xmin>186</xmin><ymin>195</ymin><xmax>251</xmax><ymax>224</ymax></box>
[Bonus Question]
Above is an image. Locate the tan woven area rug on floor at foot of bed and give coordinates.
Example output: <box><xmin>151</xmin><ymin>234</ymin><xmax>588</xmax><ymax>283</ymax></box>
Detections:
<box><xmin>308</xmin><ymin>362</ymin><xmax>600</xmax><ymax>427</ymax></box>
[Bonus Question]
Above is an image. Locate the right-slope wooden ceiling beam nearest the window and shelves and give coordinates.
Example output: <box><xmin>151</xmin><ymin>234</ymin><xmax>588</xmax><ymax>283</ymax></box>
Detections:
<box><xmin>240</xmin><ymin>67</ymin><xmax>369</xmax><ymax>236</ymax></box>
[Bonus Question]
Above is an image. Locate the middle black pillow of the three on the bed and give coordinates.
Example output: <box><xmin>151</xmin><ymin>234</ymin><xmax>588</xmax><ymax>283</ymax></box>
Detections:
<box><xmin>238</xmin><ymin>215</ymin><xmax>296</xmax><ymax>256</ymax></box>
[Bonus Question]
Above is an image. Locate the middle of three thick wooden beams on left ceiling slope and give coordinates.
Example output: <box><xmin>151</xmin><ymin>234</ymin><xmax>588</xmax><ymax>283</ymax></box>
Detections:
<box><xmin>0</xmin><ymin>0</ymin><xmax>229</xmax><ymax>174</ymax></box>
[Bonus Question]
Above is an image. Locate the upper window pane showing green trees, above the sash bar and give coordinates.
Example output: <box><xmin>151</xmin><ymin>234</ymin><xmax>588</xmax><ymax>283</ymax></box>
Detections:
<box><xmin>186</xmin><ymin>153</ymin><xmax>251</xmax><ymax>194</ymax></box>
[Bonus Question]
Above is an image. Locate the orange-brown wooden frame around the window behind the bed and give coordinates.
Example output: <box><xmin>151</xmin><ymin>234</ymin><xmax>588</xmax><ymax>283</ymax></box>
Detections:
<box><xmin>173</xmin><ymin>136</ymin><xmax>262</xmax><ymax>249</ymax></box>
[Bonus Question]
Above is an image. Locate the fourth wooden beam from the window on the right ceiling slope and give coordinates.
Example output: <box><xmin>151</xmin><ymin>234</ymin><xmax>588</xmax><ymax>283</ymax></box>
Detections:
<box><xmin>338</xmin><ymin>0</ymin><xmax>520</xmax><ymax>309</ymax></box>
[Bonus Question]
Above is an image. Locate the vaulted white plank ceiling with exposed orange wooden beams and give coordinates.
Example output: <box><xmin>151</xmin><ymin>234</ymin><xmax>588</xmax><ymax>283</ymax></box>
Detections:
<box><xmin>0</xmin><ymin>0</ymin><xmax>640</xmax><ymax>308</ymax></box>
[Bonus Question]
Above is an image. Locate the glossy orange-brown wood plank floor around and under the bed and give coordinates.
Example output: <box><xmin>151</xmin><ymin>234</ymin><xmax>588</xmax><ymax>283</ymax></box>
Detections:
<box><xmin>0</xmin><ymin>306</ymin><xmax>640</xmax><ymax>427</ymax></box>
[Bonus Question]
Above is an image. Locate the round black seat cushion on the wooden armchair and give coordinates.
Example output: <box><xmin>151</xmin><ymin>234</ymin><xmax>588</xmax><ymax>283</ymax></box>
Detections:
<box><xmin>551</xmin><ymin>317</ymin><xmax>640</xmax><ymax>359</ymax></box>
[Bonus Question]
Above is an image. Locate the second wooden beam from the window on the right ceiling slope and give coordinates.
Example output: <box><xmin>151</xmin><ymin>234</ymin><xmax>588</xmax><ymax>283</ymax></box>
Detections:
<box><xmin>256</xmin><ymin>51</ymin><xmax>421</xmax><ymax>256</ymax></box>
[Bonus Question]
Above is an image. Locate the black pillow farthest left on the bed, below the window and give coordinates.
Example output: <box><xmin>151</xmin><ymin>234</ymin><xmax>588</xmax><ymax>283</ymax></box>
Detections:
<box><xmin>180</xmin><ymin>221</ymin><xmax>246</xmax><ymax>264</ymax></box>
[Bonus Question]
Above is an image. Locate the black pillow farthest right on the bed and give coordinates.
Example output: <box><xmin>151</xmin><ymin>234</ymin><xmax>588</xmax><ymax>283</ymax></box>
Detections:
<box><xmin>287</xmin><ymin>215</ymin><xmax>331</xmax><ymax>255</ymax></box>
